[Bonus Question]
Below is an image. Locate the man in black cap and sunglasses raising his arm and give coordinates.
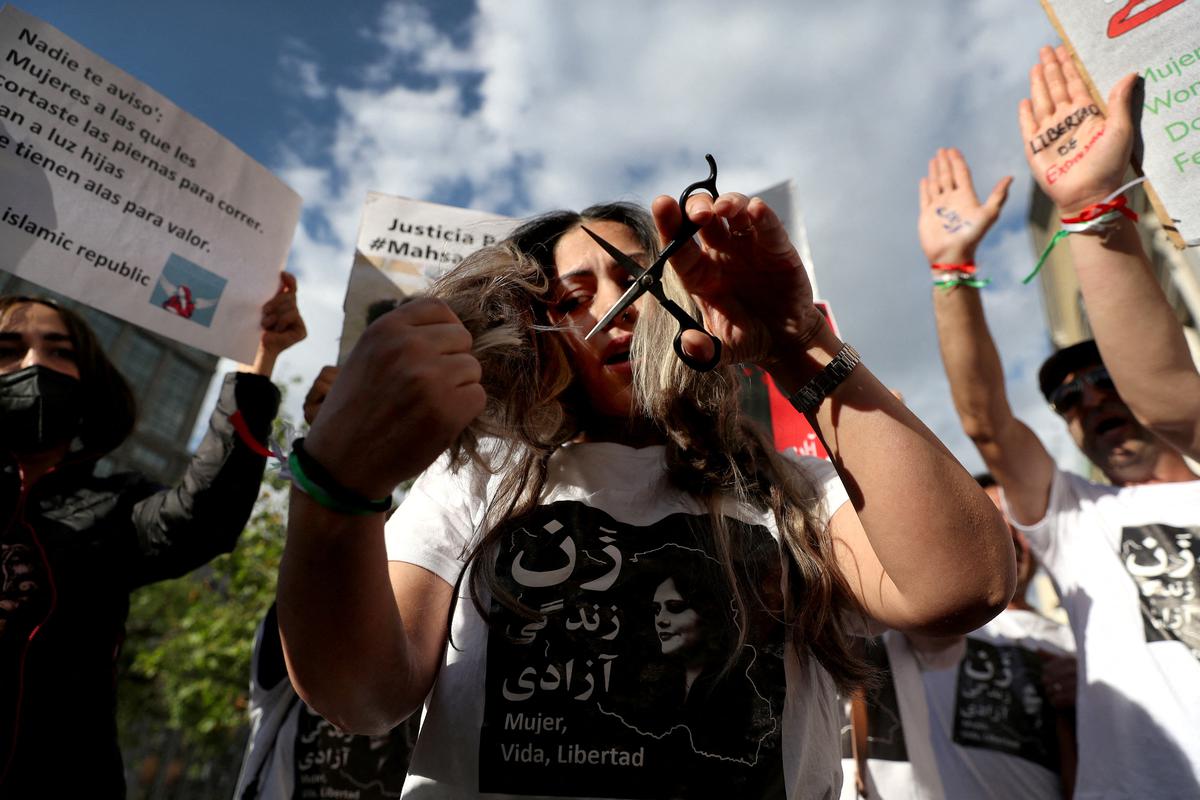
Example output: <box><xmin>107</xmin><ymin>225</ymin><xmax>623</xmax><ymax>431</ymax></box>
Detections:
<box><xmin>918</xmin><ymin>50</ymin><xmax>1200</xmax><ymax>798</ymax></box>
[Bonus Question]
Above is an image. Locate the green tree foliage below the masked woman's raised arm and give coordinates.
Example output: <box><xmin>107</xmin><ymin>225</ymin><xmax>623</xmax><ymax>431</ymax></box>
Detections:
<box><xmin>118</xmin><ymin>381</ymin><xmax>412</xmax><ymax>799</ymax></box>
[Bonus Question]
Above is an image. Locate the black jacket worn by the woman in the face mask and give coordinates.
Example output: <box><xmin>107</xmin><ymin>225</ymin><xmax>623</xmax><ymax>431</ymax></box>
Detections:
<box><xmin>0</xmin><ymin>373</ymin><xmax>280</xmax><ymax>800</ymax></box>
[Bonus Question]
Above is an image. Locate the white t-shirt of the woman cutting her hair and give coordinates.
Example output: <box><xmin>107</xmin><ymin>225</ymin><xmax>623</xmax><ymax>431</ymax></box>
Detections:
<box><xmin>386</xmin><ymin>443</ymin><xmax>847</xmax><ymax>799</ymax></box>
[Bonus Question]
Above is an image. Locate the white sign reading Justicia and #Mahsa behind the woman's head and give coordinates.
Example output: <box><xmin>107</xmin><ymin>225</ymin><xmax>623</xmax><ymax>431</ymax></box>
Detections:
<box><xmin>337</xmin><ymin>192</ymin><xmax>516</xmax><ymax>363</ymax></box>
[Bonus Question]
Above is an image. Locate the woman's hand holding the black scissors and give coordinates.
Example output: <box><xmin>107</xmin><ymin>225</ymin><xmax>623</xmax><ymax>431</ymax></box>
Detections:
<box><xmin>652</xmin><ymin>192</ymin><xmax>824</xmax><ymax>367</ymax></box>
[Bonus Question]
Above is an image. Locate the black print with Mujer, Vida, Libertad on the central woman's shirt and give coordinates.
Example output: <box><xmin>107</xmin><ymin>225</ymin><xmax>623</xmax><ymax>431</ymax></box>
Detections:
<box><xmin>479</xmin><ymin>501</ymin><xmax>785</xmax><ymax>798</ymax></box>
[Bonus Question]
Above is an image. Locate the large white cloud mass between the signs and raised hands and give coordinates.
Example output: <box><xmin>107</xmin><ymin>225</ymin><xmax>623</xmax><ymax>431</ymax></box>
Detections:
<box><xmin>265</xmin><ymin>0</ymin><xmax>1089</xmax><ymax>467</ymax></box>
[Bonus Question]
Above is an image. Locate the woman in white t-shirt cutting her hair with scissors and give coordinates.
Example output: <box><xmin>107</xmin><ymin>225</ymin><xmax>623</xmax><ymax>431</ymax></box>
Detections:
<box><xmin>277</xmin><ymin>193</ymin><xmax>1014</xmax><ymax>800</ymax></box>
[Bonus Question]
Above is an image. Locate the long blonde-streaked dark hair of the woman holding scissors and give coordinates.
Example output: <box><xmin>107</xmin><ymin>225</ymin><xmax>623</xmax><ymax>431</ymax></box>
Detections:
<box><xmin>431</xmin><ymin>203</ymin><xmax>870</xmax><ymax>688</ymax></box>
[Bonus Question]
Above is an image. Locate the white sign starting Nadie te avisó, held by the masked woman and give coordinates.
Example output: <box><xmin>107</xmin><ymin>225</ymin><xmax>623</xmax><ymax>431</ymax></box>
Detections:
<box><xmin>0</xmin><ymin>6</ymin><xmax>300</xmax><ymax>362</ymax></box>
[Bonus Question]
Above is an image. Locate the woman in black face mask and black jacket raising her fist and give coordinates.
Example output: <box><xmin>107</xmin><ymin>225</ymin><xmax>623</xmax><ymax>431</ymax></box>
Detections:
<box><xmin>0</xmin><ymin>273</ymin><xmax>305</xmax><ymax>798</ymax></box>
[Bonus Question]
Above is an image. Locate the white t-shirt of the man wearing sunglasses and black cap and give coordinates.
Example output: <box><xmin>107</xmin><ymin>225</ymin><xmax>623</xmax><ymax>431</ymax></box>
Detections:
<box><xmin>1016</xmin><ymin>471</ymin><xmax>1200</xmax><ymax>800</ymax></box>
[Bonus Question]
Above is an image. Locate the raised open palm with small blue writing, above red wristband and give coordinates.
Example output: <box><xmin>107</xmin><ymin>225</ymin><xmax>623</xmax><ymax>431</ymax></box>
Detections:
<box><xmin>917</xmin><ymin>148</ymin><xmax>1013</xmax><ymax>264</ymax></box>
